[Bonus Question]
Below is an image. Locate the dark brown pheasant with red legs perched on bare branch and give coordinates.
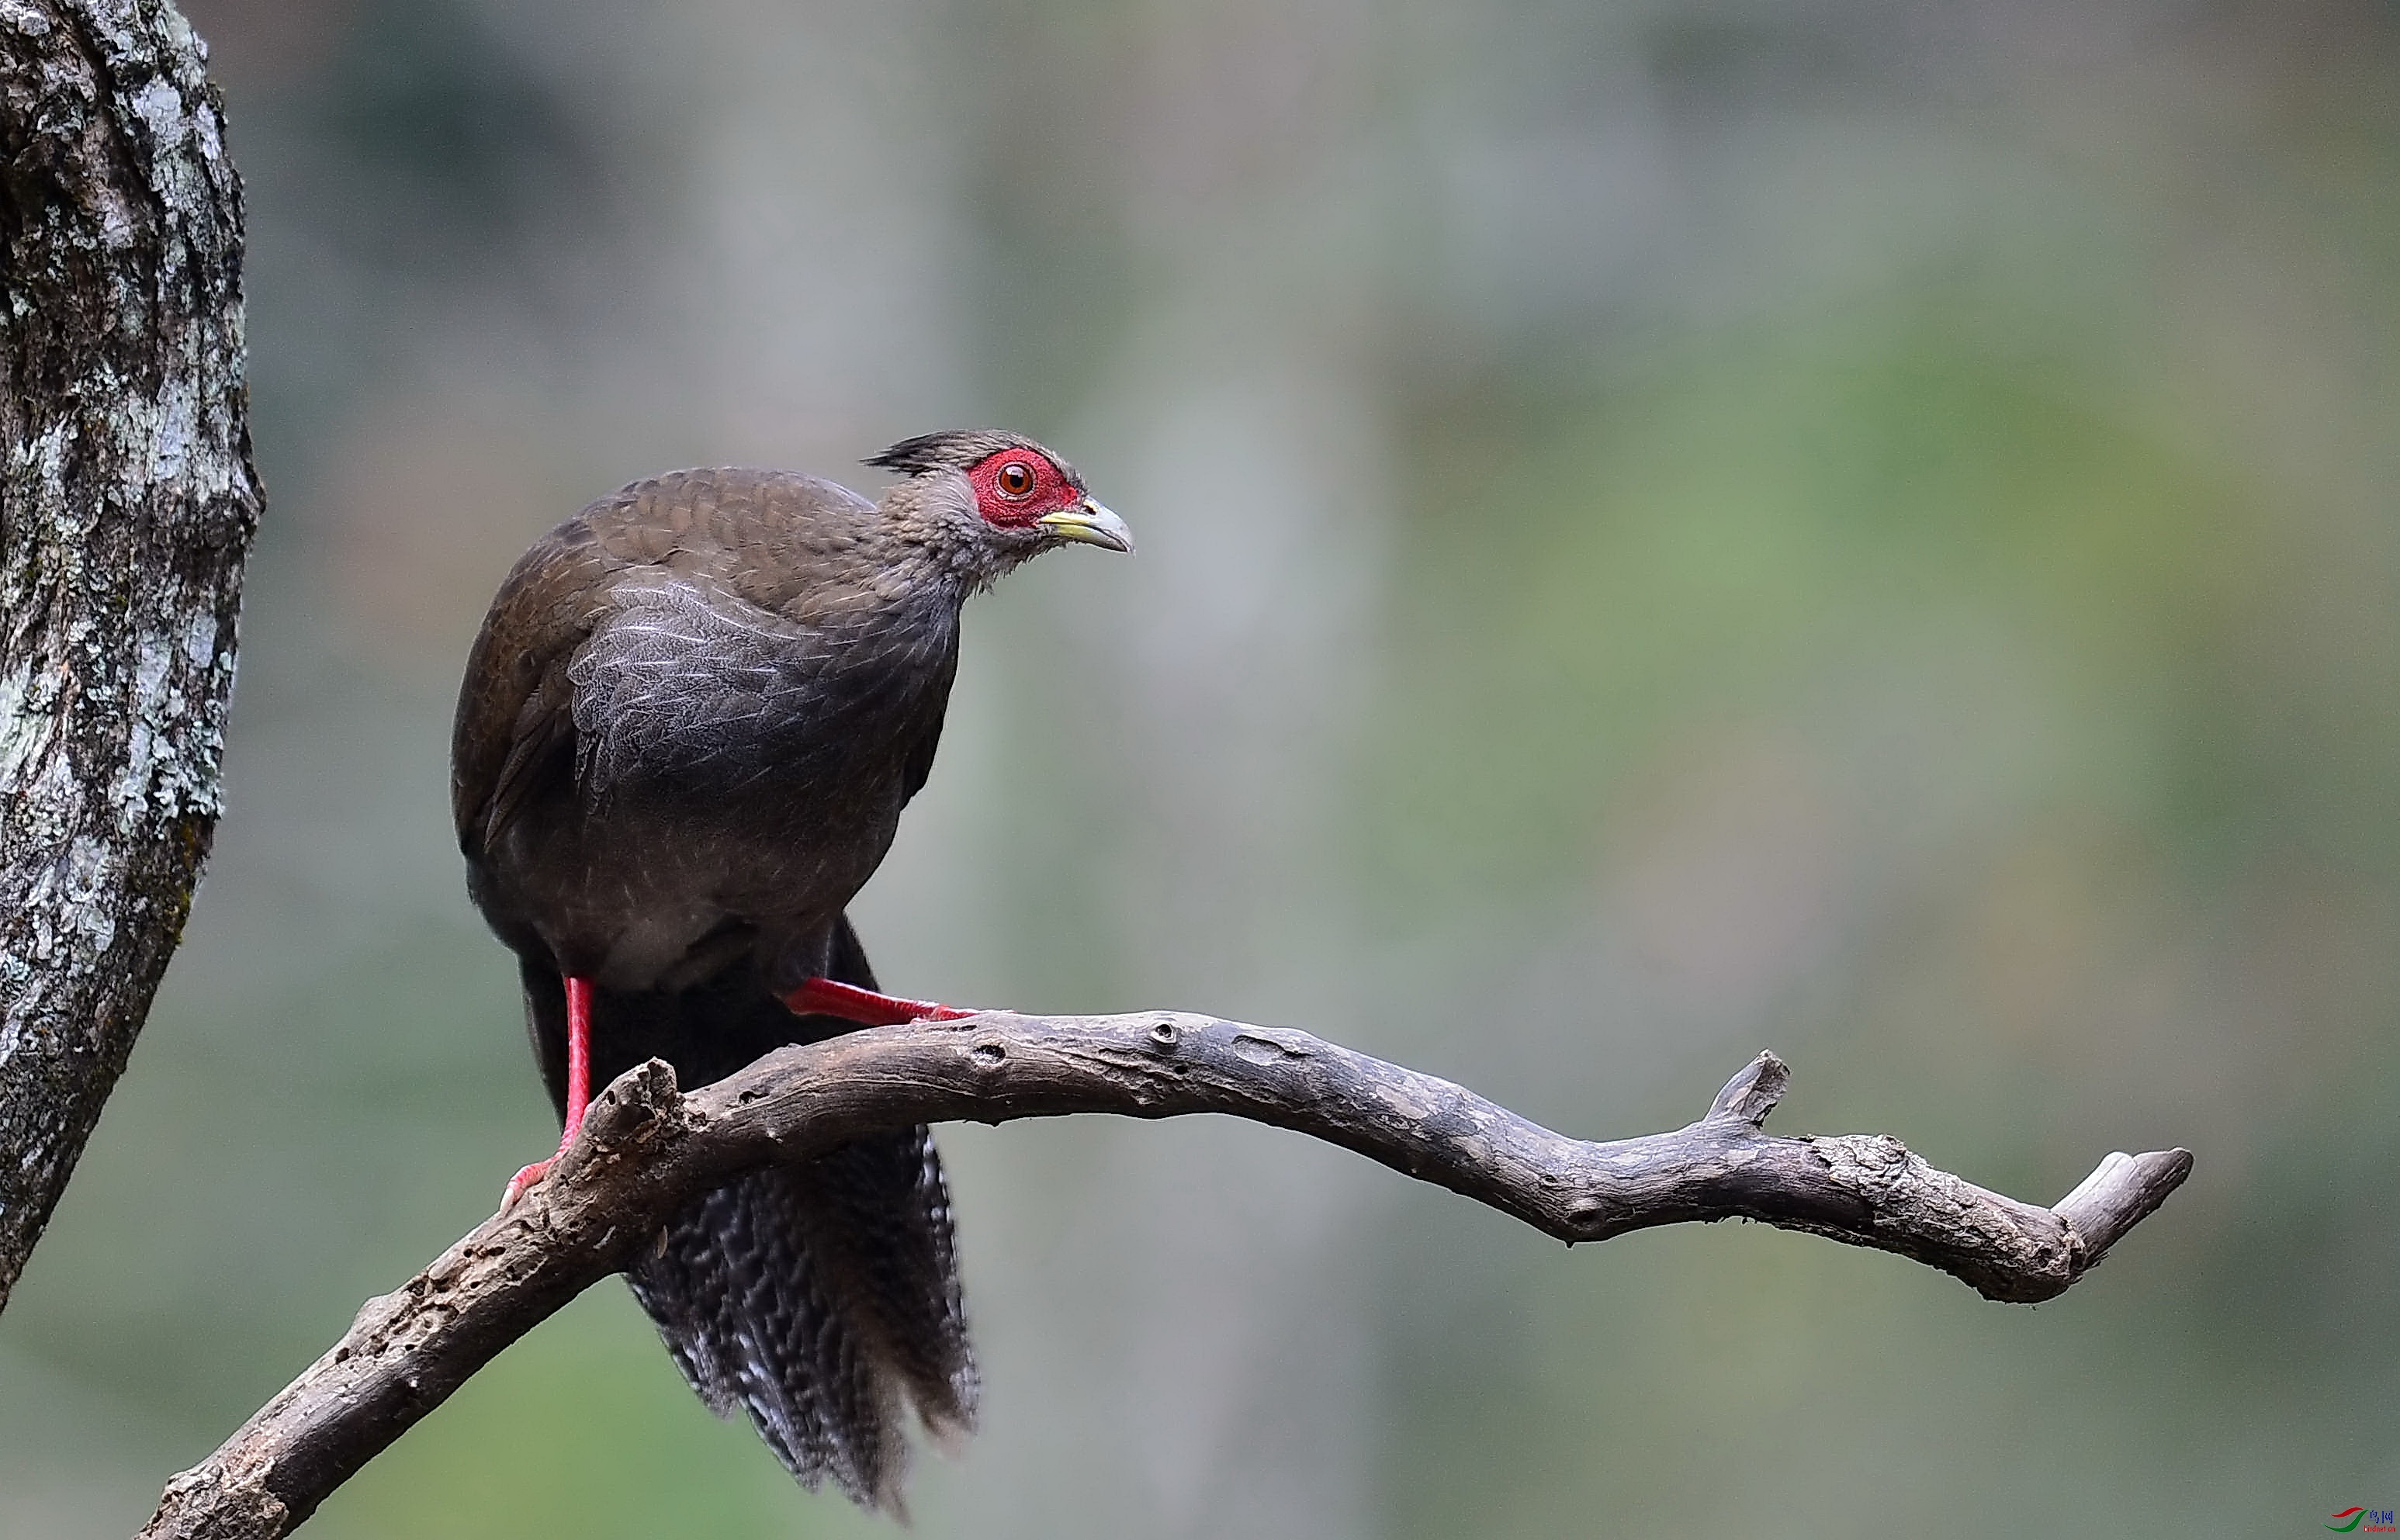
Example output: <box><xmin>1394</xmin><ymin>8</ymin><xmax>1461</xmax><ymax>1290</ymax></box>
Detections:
<box><xmin>451</xmin><ymin>432</ymin><xmax>1133</xmax><ymax>1511</ymax></box>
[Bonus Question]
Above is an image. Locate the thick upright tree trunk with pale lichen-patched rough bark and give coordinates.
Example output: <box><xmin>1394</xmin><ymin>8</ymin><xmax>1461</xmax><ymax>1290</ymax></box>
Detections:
<box><xmin>0</xmin><ymin>0</ymin><xmax>259</xmax><ymax>1307</ymax></box>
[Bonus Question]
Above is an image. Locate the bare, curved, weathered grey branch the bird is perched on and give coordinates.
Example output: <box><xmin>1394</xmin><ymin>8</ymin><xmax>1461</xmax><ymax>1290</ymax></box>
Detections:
<box><xmin>141</xmin><ymin>1012</ymin><xmax>2191</xmax><ymax>1540</ymax></box>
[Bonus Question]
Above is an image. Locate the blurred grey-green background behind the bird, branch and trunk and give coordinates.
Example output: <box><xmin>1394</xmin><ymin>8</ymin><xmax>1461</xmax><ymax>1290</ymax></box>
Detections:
<box><xmin>0</xmin><ymin>0</ymin><xmax>2400</xmax><ymax>1540</ymax></box>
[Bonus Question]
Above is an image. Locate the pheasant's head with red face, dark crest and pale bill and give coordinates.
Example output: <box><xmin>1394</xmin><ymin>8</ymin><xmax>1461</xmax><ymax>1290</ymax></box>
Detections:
<box><xmin>867</xmin><ymin>429</ymin><xmax>1133</xmax><ymax>585</ymax></box>
